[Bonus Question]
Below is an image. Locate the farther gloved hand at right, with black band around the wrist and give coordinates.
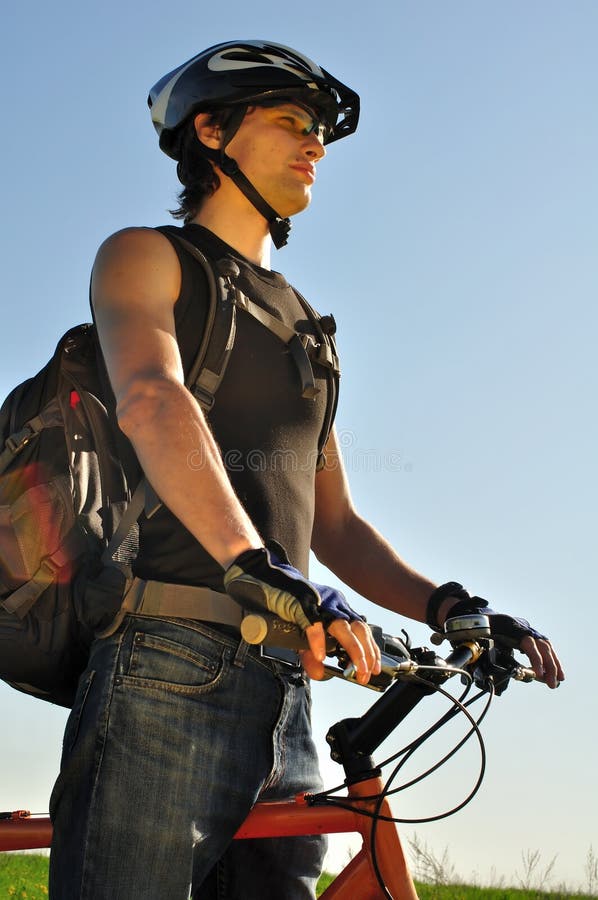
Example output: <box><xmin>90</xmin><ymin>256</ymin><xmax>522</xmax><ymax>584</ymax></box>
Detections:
<box><xmin>427</xmin><ymin>582</ymin><xmax>565</xmax><ymax>688</ymax></box>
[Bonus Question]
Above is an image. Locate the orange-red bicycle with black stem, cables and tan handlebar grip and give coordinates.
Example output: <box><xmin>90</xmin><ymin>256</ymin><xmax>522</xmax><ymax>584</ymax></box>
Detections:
<box><xmin>0</xmin><ymin>615</ymin><xmax>535</xmax><ymax>900</ymax></box>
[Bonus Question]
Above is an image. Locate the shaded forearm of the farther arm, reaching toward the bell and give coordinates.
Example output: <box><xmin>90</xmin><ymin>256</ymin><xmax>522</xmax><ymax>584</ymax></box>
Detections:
<box><xmin>313</xmin><ymin>512</ymin><xmax>436</xmax><ymax>622</ymax></box>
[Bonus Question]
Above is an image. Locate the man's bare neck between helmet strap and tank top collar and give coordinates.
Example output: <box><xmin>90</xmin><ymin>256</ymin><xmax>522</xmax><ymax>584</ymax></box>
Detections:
<box><xmin>193</xmin><ymin>179</ymin><xmax>272</xmax><ymax>269</ymax></box>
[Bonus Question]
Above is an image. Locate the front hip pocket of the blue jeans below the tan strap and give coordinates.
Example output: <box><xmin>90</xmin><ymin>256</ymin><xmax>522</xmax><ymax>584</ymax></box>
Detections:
<box><xmin>122</xmin><ymin>631</ymin><xmax>227</xmax><ymax>695</ymax></box>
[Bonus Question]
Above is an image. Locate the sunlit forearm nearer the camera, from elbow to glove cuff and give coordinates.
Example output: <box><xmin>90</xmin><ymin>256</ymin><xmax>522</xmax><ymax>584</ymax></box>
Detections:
<box><xmin>117</xmin><ymin>379</ymin><xmax>262</xmax><ymax>567</ymax></box>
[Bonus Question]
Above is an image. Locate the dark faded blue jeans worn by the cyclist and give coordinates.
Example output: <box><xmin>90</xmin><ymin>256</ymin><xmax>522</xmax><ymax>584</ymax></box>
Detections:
<box><xmin>50</xmin><ymin>616</ymin><xmax>325</xmax><ymax>900</ymax></box>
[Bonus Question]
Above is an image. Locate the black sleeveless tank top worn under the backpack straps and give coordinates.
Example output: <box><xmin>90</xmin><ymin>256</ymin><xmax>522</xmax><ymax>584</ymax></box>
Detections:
<box><xmin>135</xmin><ymin>225</ymin><xmax>336</xmax><ymax>590</ymax></box>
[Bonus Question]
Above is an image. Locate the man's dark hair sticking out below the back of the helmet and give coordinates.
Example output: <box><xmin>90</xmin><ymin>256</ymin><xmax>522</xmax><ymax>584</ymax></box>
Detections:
<box><xmin>170</xmin><ymin>109</ymin><xmax>230</xmax><ymax>225</ymax></box>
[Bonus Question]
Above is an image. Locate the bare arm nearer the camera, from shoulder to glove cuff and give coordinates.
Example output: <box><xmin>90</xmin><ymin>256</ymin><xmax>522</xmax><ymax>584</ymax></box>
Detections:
<box><xmin>92</xmin><ymin>228</ymin><xmax>262</xmax><ymax>567</ymax></box>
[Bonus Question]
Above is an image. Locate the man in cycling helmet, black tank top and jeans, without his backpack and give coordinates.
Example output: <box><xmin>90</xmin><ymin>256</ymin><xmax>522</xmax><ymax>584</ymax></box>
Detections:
<box><xmin>51</xmin><ymin>41</ymin><xmax>563</xmax><ymax>900</ymax></box>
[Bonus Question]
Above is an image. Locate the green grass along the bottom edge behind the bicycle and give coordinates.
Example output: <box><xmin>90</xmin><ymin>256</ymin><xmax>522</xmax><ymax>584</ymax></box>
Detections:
<box><xmin>0</xmin><ymin>853</ymin><xmax>589</xmax><ymax>900</ymax></box>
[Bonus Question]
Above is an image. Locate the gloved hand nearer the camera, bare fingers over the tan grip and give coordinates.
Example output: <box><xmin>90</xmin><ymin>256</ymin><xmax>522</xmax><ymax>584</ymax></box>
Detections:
<box><xmin>224</xmin><ymin>541</ymin><xmax>380</xmax><ymax>684</ymax></box>
